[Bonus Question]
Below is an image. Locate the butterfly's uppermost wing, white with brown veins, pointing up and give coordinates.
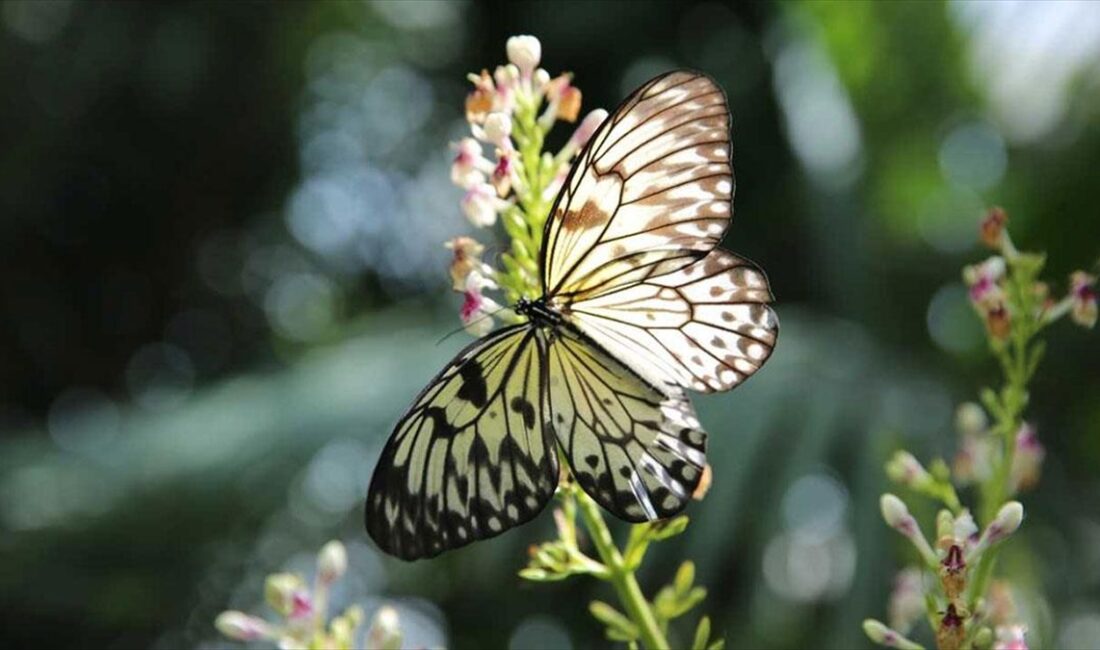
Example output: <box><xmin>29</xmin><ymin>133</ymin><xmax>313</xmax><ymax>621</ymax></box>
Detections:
<box><xmin>542</xmin><ymin>70</ymin><xmax>734</xmax><ymax>299</ymax></box>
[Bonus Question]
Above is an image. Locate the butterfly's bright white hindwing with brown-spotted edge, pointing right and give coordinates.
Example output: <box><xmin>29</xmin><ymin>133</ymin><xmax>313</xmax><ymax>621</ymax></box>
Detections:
<box><xmin>570</xmin><ymin>249</ymin><xmax>779</xmax><ymax>393</ymax></box>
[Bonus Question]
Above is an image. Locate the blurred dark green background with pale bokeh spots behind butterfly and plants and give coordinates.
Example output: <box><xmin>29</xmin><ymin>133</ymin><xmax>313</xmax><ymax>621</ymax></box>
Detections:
<box><xmin>0</xmin><ymin>1</ymin><xmax>1100</xmax><ymax>648</ymax></box>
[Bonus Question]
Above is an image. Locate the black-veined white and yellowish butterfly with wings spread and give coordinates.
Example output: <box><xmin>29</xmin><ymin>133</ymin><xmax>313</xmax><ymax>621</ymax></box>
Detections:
<box><xmin>365</xmin><ymin>70</ymin><xmax>779</xmax><ymax>560</ymax></box>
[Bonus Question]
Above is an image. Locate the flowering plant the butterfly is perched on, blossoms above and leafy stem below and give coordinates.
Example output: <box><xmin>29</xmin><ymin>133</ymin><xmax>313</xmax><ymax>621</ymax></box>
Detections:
<box><xmin>446</xmin><ymin>36</ymin><xmax>723</xmax><ymax>649</ymax></box>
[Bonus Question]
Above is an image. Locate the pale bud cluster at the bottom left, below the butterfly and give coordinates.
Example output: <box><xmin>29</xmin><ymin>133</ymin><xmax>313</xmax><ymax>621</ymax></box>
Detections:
<box><xmin>215</xmin><ymin>541</ymin><xmax>402</xmax><ymax>650</ymax></box>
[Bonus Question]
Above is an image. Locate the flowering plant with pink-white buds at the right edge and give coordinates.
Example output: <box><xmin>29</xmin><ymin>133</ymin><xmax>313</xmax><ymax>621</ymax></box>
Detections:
<box><xmin>864</xmin><ymin>208</ymin><xmax>1097</xmax><ymax>650</ymax></box>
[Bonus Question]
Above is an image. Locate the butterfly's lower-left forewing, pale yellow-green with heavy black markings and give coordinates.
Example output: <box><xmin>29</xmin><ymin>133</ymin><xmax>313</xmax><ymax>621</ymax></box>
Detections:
<box><xmin>365</xmin><ymin>324</ymin><xmax>558</xmax><ymax>560</ymax></box>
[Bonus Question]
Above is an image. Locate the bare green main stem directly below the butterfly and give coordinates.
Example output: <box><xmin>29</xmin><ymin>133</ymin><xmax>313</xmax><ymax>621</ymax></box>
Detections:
<box><xmin>573</xmin><ymin>488</ymin><xmax>669</xmax><ymax>650</ymax></box>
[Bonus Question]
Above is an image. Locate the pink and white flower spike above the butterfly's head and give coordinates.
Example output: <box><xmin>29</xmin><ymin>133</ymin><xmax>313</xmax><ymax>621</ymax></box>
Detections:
<box><xmin>447</xmin><ymin>36</ymin><xmax>607</xmax><ymax>335</ymax></box>
